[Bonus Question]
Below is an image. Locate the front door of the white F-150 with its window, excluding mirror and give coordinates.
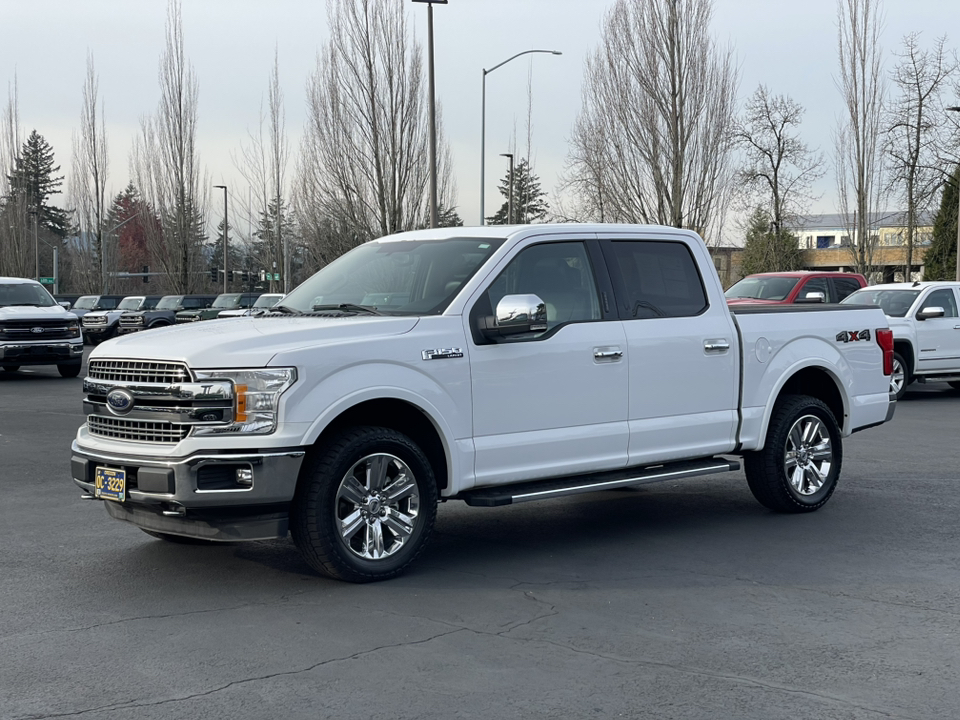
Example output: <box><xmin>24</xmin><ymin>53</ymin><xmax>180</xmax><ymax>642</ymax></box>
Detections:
<box><xmin>469</xmin><ymin>240</ymin><xmax>628</xmax><ymax>486</ymax></box>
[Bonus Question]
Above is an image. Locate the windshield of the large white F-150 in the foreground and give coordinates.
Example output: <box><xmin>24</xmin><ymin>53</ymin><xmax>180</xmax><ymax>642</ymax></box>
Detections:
<box><xmin>279</xmin><ymin>238</ymin><xmax>503</xmax><ymax>315</ymax></box>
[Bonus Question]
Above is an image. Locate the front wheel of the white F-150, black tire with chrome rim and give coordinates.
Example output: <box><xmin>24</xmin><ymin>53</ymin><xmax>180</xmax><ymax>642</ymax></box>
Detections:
<box><xmin>290</xmin><ymin>427</ymin><xmax>437</xmax><ymax>582</ymax></box>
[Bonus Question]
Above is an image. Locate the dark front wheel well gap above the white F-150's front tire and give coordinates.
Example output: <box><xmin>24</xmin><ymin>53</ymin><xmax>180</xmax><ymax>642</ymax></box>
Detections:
<box><xmin>317</xmin><ymin>398</ymin><xmax>449</xmax><ymax>490</ymax></box>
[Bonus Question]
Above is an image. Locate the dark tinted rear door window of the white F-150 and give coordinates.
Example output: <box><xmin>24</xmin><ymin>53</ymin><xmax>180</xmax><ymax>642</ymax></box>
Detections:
<box><xmin>609</xmin><ymin>240</ymin><xmax>707</xmax><ymax>319</ymax></box>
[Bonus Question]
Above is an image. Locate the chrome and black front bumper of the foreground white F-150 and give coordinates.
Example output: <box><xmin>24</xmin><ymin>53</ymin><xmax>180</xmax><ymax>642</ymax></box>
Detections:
<box><xmin>70</xmin><ymin>441</ymin><xmax>304</xmax><ymax>541</ymax></box>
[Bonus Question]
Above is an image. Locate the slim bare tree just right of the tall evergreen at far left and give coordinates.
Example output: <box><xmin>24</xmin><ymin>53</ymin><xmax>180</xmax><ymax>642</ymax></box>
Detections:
<box><xmin>70</xmin><ymin>54</ymin><xmax>109</xmax><ymax>292</ymax></box>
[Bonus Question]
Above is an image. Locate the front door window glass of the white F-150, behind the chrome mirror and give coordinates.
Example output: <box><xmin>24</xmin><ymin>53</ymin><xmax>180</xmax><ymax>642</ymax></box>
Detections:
<box><xmin>486</xmin><ymin>242</ymin><xmax>600</xmax><ymax>332</ymax></box>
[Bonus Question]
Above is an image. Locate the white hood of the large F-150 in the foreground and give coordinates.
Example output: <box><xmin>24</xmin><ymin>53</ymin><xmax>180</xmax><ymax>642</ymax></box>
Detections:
<box><xmin>90</xmin><ymin>315</ymin><xmax>420</xmax><ymax>368</ymax></box>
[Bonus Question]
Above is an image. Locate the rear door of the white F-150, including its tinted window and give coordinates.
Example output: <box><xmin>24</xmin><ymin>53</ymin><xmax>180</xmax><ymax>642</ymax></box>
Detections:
<box><xmin>601</xmin><ymin>235</ymin><xmax>740</xmax><ymax>465</ymax></box>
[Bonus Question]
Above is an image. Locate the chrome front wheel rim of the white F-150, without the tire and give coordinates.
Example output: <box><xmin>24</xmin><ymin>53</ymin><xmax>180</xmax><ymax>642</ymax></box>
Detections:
<box><xmin>336</xmin><ymin>453</ymin><xmax>420</xmax><ymax>560</ymax></box>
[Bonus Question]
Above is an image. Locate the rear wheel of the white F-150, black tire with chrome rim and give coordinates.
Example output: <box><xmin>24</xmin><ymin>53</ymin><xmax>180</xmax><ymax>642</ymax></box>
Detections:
<box><xmin>743</xmin><ymin>395</ymin><xmax>843</xmax><ymax>513</ymax></box>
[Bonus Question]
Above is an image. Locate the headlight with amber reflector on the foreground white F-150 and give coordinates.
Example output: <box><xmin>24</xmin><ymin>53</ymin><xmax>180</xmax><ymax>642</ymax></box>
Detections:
<box><xmin>193</xmin><ymin>368</ymin><xmax>297</xmax><ymax>435</ymax></box>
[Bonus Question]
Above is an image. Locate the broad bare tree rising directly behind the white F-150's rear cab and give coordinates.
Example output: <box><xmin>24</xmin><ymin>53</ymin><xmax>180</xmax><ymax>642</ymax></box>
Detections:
<box><xmin>566</xmin><ymin>0</ymin><xmax>738</xmax><ymax>242</ymax></box>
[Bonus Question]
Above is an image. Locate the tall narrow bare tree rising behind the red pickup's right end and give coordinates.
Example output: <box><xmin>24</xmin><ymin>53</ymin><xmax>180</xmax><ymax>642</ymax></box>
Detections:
<box><xmin>835</xmin><ymin>0</ymin><xmax>885</xmax><ymax>275</ymax></box>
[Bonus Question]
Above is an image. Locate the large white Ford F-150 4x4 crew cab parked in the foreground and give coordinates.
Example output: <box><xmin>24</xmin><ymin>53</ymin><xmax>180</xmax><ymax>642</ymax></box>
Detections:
<box><xmin>72</xmin><ymin>225</ymin><xmax>895</xmax><ymax>582</ymax></box>
